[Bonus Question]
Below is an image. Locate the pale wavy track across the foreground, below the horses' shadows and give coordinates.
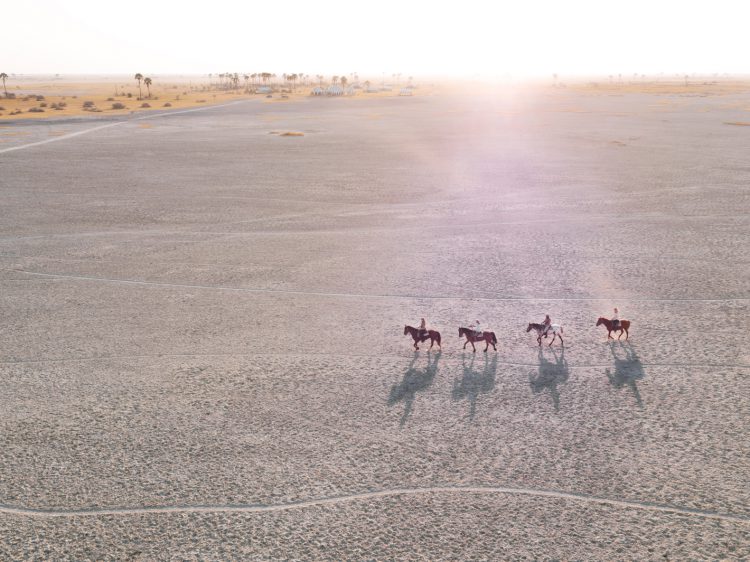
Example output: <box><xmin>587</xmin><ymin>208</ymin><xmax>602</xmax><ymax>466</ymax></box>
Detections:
<box><xmin>0</xmin><ymin>486</ymin><xmax>750</xmax><ymax>524</ymax></box>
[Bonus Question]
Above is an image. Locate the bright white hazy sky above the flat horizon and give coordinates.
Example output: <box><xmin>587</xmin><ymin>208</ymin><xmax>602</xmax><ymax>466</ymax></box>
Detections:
<box><xmin>5</xmin><ymin>0</ymin><xmax>750</xmax><ymax>78</ymax></box>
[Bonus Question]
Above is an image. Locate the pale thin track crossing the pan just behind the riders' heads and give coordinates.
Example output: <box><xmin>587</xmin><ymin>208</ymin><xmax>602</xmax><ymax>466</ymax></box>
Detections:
<box><xmin>5</xmin><ymin>268</ymin><xmax>750</xmax><ymax>302</ymax></box>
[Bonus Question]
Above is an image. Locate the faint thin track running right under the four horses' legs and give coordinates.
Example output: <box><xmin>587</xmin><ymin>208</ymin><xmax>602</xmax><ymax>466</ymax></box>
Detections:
<box><xmin>0</xmin><ymin>348</ymin><xmax>750</xmax><ymax>369</ymax></box>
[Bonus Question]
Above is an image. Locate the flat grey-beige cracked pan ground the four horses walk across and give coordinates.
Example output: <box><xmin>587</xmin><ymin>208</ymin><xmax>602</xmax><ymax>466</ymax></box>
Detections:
<box><xmin>0</xmin><ymin>85</ymin><xmax>750</xmax><ymax>560</ymax></box>
